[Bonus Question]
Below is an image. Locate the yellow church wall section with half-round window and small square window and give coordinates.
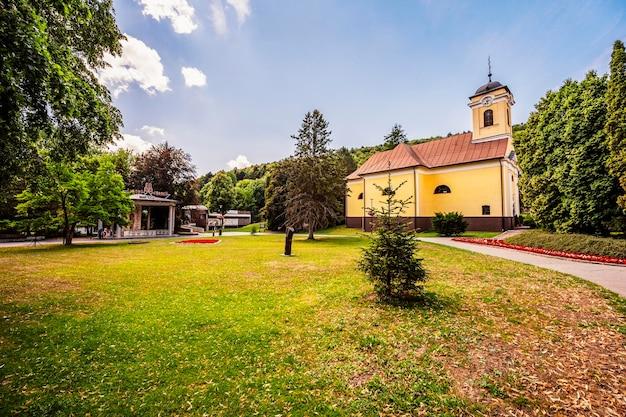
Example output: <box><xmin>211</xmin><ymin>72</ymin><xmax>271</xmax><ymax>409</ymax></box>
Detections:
<box><xmin>418</xmin><ymin>164</ymin><xmax>502</xmax><ymax>217</ymax></box>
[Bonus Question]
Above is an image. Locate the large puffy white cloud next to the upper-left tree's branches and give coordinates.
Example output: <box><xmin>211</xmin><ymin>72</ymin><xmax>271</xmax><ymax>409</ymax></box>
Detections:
<box><xmin>98</xmin><ymin>35</ymin><xmax>170</xmax><ymax>97</ymax></box>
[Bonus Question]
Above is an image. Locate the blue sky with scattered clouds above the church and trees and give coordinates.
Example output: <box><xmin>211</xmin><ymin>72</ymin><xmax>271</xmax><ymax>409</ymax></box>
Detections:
<box><xmin>102</xmin><ymin>0</ymin><xmax>626</xmax><ymax>174</ymax></box>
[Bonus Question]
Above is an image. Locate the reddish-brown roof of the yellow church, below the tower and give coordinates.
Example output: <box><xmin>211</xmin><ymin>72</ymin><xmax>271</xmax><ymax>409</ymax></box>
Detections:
<box><xmin>347</xmin><ymin>132</ymin><xmax>508</xmax><ymax>179</ymax></box>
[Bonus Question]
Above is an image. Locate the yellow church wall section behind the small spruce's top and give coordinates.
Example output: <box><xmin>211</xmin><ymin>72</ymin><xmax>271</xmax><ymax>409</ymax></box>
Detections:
<box><xmin>365</xmin><ymin>168</ymin><xmax>415</xmax><ymax>217</ymax></box>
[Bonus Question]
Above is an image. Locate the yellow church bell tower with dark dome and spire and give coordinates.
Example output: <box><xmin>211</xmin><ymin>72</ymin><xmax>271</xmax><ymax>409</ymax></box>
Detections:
<box><xmin>468</xmin><ymin>59</ymin><xmax>515</xmax><ymax>142</ymax></box>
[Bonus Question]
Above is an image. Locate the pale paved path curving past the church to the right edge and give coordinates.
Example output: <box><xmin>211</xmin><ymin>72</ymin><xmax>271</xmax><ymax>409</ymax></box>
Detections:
<box><xmin>419</xmin><ymin>237</ymin><xmax>626</xmax><ymax>297</ymax></box>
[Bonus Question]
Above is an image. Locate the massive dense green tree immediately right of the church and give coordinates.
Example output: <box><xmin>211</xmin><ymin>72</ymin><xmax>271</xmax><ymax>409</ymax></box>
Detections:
<box><xmin>514</xmin><ymin>72</ymin><xmax>619</xmax><ymax>233</ymax></box>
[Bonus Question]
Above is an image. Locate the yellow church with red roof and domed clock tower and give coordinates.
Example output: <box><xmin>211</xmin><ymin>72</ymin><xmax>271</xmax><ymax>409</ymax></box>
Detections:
<box><xmin>345</xmin><ymin>73</ymin><xmax>520</xmax><ymax>231</ymax></box>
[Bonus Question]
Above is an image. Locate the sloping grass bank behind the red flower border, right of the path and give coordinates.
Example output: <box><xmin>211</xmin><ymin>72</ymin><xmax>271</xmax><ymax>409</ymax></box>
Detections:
<box><xmin>506</xmin><ymin>230</ymin><xmax>626</xmax><ymax>258</ymax></box>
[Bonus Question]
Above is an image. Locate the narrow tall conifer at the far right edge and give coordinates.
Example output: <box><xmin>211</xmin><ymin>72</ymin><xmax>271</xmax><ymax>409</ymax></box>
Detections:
<box><xmin>606</xmin><ymin>40</ymin><xmax>626</xmax><ymax>213</ymax></box>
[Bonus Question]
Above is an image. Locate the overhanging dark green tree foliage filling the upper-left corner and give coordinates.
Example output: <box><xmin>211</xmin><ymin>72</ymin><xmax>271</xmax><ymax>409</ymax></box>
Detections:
<box><xmin>0</xmin><ymin>0</ymin><xmax>122</xmax><ymax>187</ymax></box>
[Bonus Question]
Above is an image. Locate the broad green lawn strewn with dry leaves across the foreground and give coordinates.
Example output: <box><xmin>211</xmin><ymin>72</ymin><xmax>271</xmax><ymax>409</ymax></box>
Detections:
<box><xmin>0</xmin><ymin>235</ymin><xmax>626</xmax><ymax>416</ymax></box>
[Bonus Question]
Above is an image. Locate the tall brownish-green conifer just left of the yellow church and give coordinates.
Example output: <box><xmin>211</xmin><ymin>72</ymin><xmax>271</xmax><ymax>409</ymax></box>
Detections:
<box><xmin>286</xmin><ymin>110</ymin><xmax>345</xmax><ymax>239</ymax></box>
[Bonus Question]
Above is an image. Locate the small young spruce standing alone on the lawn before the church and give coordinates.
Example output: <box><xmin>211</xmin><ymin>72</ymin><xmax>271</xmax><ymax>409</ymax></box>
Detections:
<box><xmin>359</xmin><ymin>174</ymin><xmax>426</xmax><ymax>301</ymax></box>
